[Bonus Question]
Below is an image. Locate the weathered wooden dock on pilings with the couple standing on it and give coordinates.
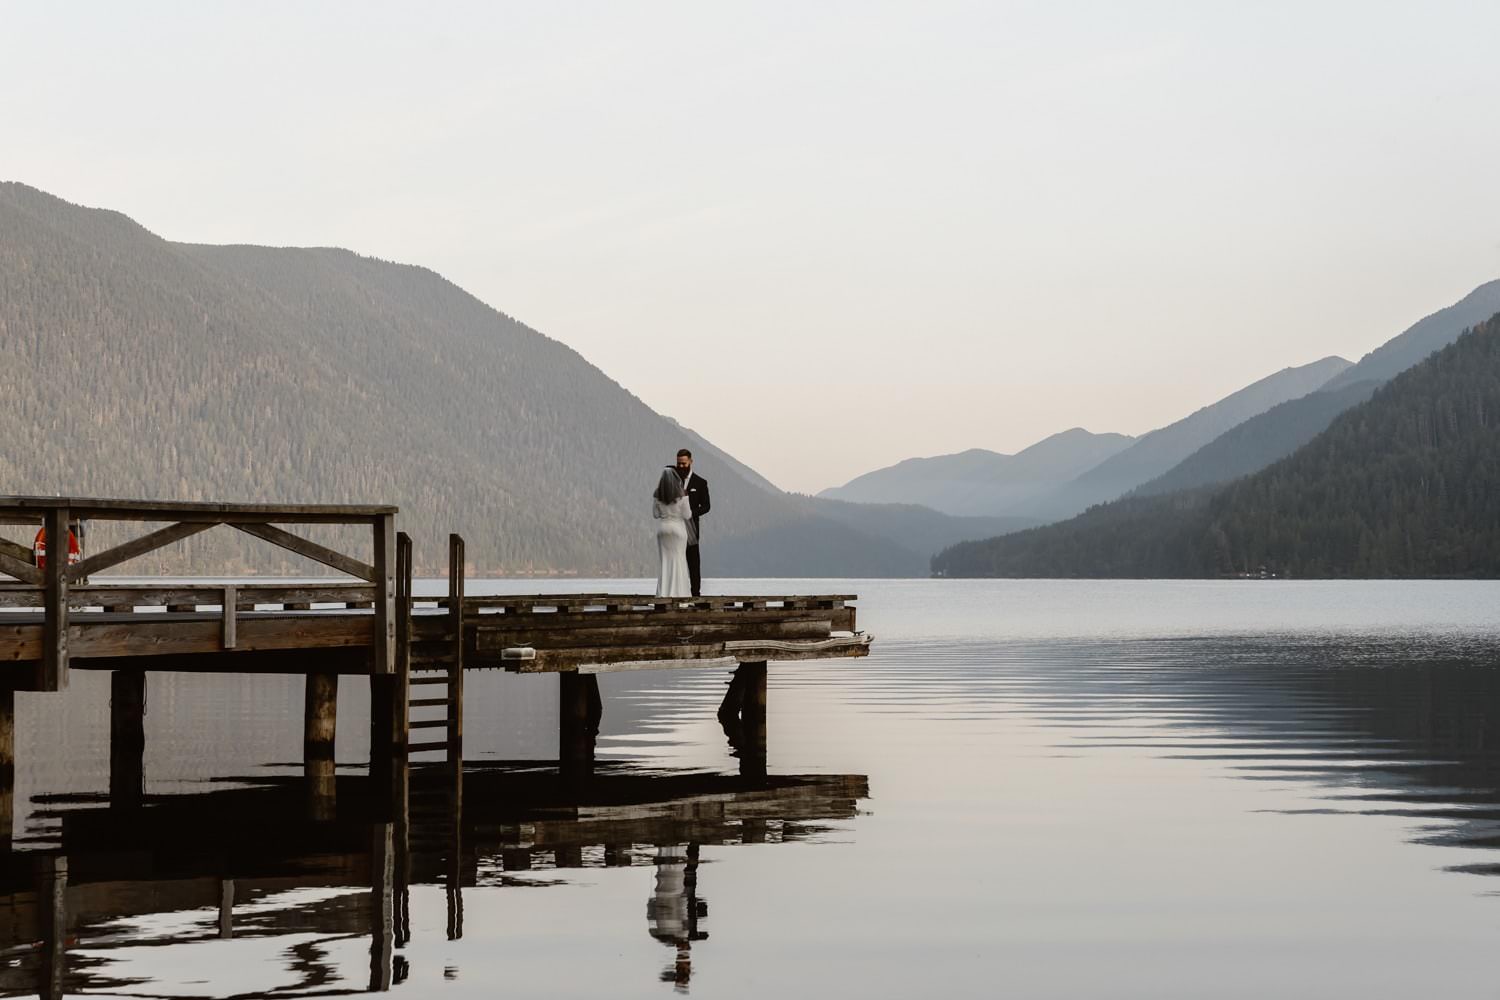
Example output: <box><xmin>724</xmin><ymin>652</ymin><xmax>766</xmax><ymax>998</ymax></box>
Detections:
<box><xmin>0</xmin><ymin>496</ymin><xmax>870</xmax><ymax>826</ymax></box>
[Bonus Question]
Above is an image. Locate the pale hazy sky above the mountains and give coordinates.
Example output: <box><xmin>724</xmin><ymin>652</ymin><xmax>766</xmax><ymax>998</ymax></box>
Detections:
<box><xmin>0</xmin><ymin>0</ymin><xmax>1500</xmax><ymax>492</ymax></box>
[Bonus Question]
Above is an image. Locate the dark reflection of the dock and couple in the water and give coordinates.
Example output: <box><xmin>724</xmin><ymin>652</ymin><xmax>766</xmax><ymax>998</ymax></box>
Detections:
<box><xmin>0</xmin><ymin>762</ymin><xmax>869</xmax><ymax>997</ymax></box>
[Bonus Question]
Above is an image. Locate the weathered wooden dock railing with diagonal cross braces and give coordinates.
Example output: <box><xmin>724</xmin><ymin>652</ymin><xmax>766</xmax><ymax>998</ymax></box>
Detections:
<box><xmin>0</xmin><ymin>496</ymin><xmax>396</xmax><ymax>691</ymax></box>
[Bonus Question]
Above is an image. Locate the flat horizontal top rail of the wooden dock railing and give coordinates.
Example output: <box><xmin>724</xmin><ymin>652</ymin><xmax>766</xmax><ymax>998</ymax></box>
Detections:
<box><xmin>0</xmin><ymin>496</ymin><xmax>398</xmax><ymax>525</ymax></box>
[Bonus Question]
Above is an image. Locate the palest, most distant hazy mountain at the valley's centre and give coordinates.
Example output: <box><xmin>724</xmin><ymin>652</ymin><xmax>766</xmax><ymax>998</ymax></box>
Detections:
<box><xmin>819</xmin><ymin>427</ymin><xmax>1134</xmax><ymax>520</ymax></box>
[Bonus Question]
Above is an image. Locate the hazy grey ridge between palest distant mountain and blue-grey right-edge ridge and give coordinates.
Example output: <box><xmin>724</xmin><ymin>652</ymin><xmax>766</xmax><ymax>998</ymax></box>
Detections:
<box><xmin>1013</xmin><ymin>357</ymin><xmax>1350</xmax><ymax>520</ymax></box>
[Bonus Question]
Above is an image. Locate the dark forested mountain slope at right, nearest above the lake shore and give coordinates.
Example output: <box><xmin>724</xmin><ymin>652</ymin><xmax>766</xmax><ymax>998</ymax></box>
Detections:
<box><xmin>933</xmin><ymin>315</ymin><xmax>1500</xmax><ymax>577</ymax></box>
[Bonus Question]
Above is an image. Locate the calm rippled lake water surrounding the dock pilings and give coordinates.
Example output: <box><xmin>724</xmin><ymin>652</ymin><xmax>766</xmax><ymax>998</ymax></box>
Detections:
<box><xmin>0</xmin><ymin>580</ymin><xmax>1500</xmax><ymax>999</ymax></box>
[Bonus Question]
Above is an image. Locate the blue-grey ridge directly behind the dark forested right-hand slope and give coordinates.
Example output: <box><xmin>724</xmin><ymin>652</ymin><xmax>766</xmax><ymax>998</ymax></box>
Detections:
<box><xmin>1136</xmin><ymin>280</ymin><xmax>1500</xmax><ymax>495</ymax></box>
